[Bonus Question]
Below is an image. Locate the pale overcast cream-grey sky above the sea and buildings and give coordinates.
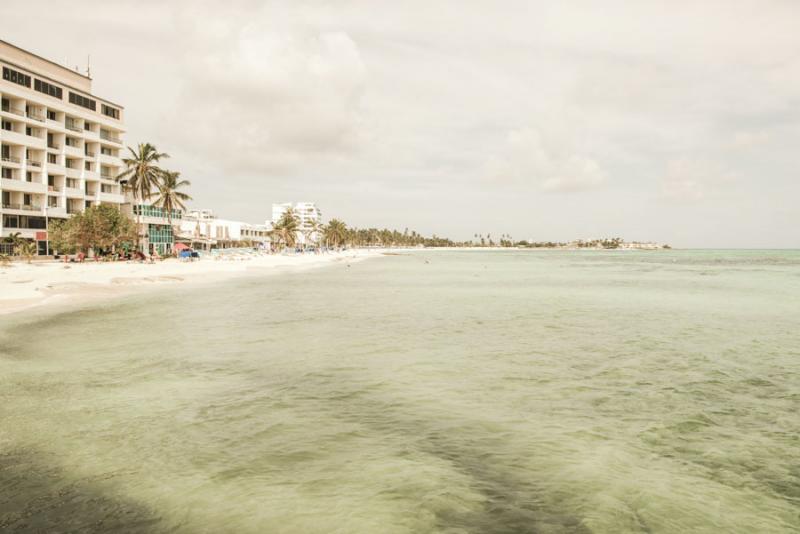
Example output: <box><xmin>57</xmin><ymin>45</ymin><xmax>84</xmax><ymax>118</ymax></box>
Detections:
<box><xmin>0</xmin><ymin>0</ymin><xmax>800</xmax><ymax>248</ymax></box>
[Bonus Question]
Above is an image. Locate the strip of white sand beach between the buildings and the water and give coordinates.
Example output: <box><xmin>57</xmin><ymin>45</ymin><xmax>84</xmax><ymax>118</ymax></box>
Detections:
<box><xmin>0</xmin><ymin>250</ymin><xmax>382</xmax><ymax>315</ymax></box>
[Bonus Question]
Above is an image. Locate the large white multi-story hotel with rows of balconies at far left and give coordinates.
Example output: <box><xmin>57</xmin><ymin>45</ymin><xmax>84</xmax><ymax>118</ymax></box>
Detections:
<box><xmin>0</xmin><ymin>41</ymin><xmax>125</xmax><ymax>254</ymax></box>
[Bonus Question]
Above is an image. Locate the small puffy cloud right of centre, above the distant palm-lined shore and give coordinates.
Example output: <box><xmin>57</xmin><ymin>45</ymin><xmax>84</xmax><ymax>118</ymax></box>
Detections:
<box><xmin>486</xmin><ymin>128</ymin><xmax>606</xmax><ymax>192</ymax></box>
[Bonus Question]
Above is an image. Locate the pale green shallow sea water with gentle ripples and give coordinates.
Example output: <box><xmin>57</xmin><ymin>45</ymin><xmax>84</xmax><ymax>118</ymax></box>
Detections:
<box><xmin>0</xmin><ymin>251</ymin><xmax>800</xmax><ymax>533</ymax></box>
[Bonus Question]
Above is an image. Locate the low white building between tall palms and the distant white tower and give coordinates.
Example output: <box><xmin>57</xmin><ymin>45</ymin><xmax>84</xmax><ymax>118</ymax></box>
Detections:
<box><xmin>178</xmin><ymin>209</ymin><xmax>270</xmax><ymax>249</ymax></box>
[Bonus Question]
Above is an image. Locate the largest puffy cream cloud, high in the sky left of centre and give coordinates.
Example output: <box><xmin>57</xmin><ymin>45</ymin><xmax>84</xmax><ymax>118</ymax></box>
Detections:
<box><xmin>170</xmin><ymin>16</ymin><xmax>367</xmax><ymax>173</ymax></box>
